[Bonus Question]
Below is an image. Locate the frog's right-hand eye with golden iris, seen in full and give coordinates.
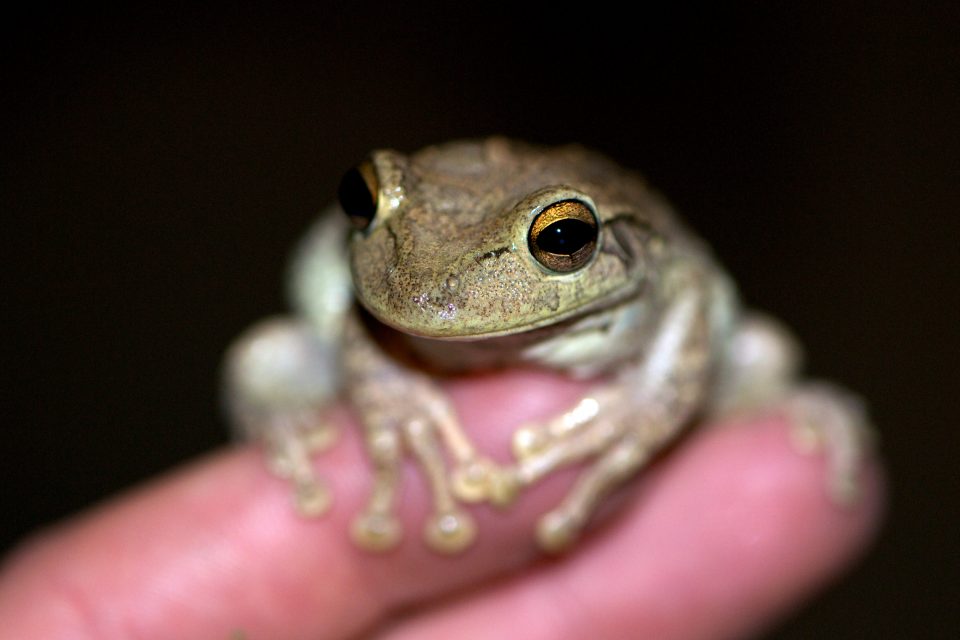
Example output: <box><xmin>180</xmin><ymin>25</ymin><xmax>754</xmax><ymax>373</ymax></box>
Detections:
<box><xmin>527</xmin><ymin>200</ymin><xmax>598</xmax><ymax>273</ymax></box>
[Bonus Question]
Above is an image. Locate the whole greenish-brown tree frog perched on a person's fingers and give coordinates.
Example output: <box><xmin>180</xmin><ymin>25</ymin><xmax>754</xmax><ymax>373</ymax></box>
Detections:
<box><xmin>224</xmin><ymin>136</ymin><xmax>871</xmax><ymax>554</ymax></box>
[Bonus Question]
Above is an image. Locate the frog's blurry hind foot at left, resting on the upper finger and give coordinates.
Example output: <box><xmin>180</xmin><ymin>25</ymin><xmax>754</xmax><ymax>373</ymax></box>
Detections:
<box><xmin>264</xmin><ymin>411</ymin><xmax>338</xmax><ymax>517</ymax></box>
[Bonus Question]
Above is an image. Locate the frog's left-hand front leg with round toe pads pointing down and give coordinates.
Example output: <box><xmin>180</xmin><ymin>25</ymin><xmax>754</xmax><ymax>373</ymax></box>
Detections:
<box><xmin>343</xmin><ymin>315</ymin><xmax>492</xmax><ymax>553</ymax></box>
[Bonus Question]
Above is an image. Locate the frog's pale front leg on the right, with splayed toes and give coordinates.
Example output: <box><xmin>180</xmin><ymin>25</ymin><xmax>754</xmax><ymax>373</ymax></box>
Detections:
<box><xmin>492</xmin><ymin>278</ymin><xmax>714</xmax><ymax>551</ymax></box>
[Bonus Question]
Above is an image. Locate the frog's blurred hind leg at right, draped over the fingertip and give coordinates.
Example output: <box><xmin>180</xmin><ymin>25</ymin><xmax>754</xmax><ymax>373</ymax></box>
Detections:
<box><xmin>709</xmin><ymin>314</ymin><xmax>876</xmax><ymax>504</ymax></box>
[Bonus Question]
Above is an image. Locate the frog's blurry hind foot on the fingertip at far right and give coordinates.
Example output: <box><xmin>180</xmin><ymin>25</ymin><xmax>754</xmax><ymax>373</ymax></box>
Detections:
<box><xmin>782</xmin><ymin>382</ymin><xmax>877</xmax><ymax>505</ymax></box>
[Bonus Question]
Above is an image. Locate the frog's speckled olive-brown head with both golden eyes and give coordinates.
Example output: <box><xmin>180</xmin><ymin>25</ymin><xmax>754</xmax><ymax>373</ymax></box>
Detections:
<box><xmin>339</xmin><ymin>138</ymin><xmax>667</xmax><ymax>340</ymax></box>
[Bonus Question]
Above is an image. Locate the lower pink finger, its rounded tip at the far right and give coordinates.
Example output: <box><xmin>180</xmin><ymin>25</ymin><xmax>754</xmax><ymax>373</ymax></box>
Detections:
<box><xmin>378</xmin><ymin>421</ymin><xmax>883</xmax><ymax>640</ymax></box>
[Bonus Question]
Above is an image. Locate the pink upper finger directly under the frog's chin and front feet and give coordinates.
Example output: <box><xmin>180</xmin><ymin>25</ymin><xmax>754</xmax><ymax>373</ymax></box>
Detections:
<box><xmin>0</xmin><ymin>372</ymin><xmax>583</xmax><ymax>640</ymax></box>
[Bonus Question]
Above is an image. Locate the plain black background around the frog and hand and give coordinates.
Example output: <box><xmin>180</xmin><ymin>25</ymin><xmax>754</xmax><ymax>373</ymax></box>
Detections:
<box><xmin>0</xmin><ymin>2</ymin><xmax>960</xmax><ymax>638</ymax></box>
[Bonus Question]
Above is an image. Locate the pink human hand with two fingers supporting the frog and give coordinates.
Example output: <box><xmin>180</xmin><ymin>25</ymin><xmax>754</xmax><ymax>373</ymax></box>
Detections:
<box><xmin>0</xmin><ymin>371</ymin><xmax>884</xmax><ymax>640</ymax></box>
